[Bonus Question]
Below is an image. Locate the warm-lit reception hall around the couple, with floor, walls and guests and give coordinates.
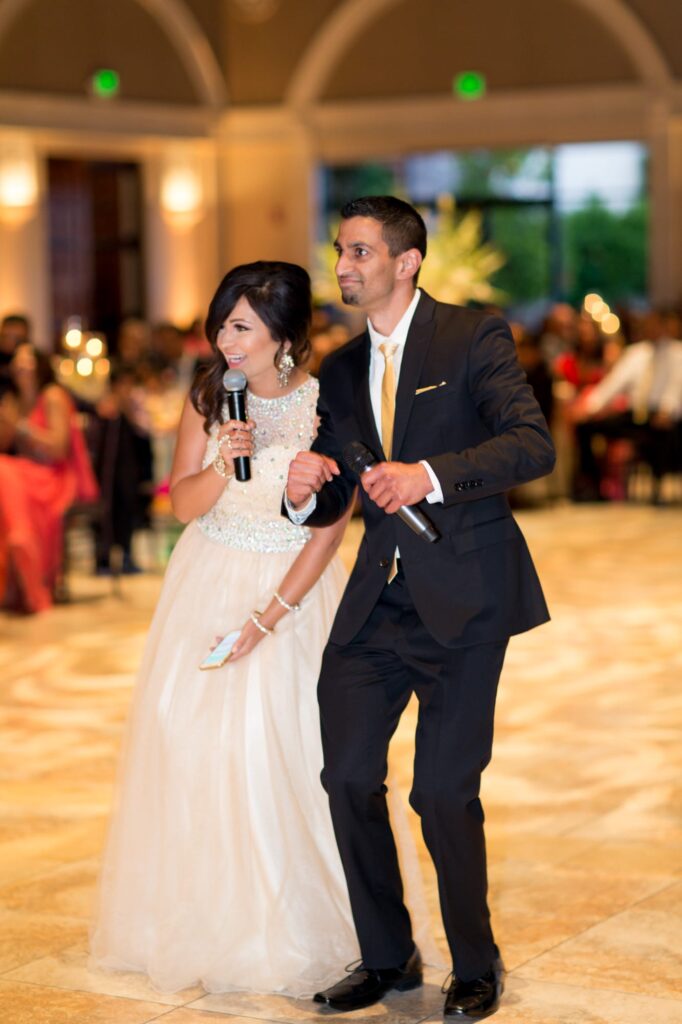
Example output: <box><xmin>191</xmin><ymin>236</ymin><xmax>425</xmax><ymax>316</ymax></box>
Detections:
<box><xmin>0</xmin><ymin>0</ymin><xmax>682</xmax><ymax>1024</ymax></box>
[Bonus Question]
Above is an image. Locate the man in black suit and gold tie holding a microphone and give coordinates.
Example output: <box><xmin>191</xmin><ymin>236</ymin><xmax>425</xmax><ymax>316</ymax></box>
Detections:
<box><xmin>285</xmin><ymin>197</ymin><xmax>554</xmax><ymax>1020</ymax></box>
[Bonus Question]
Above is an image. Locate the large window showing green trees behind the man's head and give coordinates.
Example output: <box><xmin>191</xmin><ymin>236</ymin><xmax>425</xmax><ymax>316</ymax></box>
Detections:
<box><xmin>321</xmin><ymin>142</ymin><xmax>648</xmax><ymax>308</ymax></box>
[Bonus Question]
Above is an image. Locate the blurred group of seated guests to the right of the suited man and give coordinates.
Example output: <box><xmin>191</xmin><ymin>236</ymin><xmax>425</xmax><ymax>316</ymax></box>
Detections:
<box><xmin>511</xmin><ymin>303</ymin><xmax>682</xmax><ymax>503</ymax></box>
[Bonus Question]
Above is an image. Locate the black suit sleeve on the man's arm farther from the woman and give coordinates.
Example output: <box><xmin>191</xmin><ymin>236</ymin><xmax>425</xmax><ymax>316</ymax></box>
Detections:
<box><xmin>426</xmin><ymin>316</ymin><xmax>555</xmax><ymax>506</ymax></box>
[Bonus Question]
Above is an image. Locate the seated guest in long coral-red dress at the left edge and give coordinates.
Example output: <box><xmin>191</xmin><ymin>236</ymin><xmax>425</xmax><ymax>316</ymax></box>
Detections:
<box><xmin>0</xmin><ymin>344</ymin><xmax>97</xmax><ymax>612</ymax></box>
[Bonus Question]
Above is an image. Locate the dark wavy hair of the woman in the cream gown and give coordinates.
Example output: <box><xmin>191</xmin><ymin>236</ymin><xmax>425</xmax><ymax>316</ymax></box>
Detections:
<box><xmin>189</xmin><ymin>260</ymin><xmax>312</xmax><ymax>432</ymax></box>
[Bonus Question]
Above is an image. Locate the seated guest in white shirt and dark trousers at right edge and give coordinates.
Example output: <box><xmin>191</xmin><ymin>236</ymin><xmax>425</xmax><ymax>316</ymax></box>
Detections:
<box><xmin>576</xmin><ymin>312</ymin><xmax>682</xmax><ymax>501</ymax></box>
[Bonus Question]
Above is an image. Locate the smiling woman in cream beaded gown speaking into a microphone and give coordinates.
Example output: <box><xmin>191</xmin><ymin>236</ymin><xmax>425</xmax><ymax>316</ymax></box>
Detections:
<box><xmin>91</xmin><ymin>262</ymin><xmax>432</xmax><ymax>996</ymax></box>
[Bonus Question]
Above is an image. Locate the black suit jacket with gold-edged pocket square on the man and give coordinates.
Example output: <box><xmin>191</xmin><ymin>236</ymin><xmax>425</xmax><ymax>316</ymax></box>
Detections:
<box><xmin>307</xmin><ymin>293</ymin><xmax>554</xmax><ymax>647</ymax></box>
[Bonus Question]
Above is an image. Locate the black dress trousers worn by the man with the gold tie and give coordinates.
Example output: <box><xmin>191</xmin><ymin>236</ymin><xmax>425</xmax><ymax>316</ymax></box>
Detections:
<box><xmin>318</xmin><ymin>571</ymin><xmax>507</xmax><ymax>981</ymax></box>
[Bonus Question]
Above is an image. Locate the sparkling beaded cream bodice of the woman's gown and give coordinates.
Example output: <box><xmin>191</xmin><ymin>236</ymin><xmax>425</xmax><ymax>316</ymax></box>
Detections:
<box><xmin>197</xmin><ymin>377</ymin><xmax>318</xmax><ymax>552</ymax></box>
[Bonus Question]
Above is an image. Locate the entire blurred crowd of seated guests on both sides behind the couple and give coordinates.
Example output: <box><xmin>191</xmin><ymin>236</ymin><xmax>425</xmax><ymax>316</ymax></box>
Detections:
<box><xmin>0</xmin><ymin>303</ymin><xmax>682</xmax><ymax>611</ymax></box>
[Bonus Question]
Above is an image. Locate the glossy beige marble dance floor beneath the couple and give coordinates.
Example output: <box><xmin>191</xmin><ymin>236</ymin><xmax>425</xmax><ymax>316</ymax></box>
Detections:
<box><xmin>0</xmin><ymin>506</ymin><xmax>682</xmax><ymax>1024</ymax></box>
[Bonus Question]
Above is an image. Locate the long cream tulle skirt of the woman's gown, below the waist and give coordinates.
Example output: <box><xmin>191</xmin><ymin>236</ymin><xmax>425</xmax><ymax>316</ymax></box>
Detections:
<box><xmin>91</xmin><ymin>523</ymin><xmax>358</xmax><ymax>995</ymax></box>
